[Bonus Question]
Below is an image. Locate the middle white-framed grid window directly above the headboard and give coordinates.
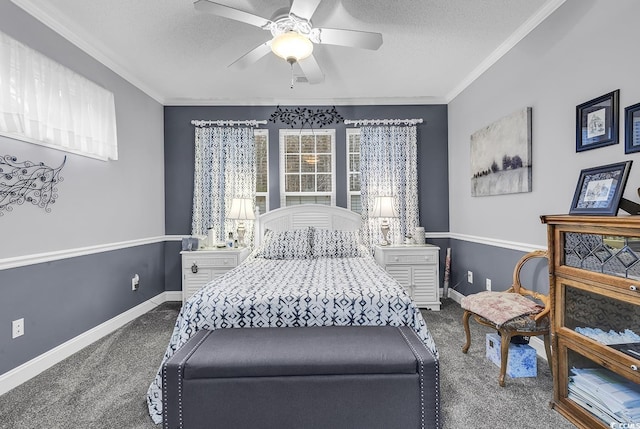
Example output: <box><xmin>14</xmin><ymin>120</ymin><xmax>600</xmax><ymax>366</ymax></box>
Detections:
<box><xmin>280</xmin><ymin>130</ymin><xmax>336</xmax><ymax>207</ymax></box>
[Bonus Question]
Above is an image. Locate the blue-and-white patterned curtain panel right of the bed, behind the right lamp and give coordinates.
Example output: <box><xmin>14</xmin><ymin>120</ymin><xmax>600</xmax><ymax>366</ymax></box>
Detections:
<box><xmin>360</xmin><ymin>126</ymin><xmax>419</xmax><ymax>246</ymax></box>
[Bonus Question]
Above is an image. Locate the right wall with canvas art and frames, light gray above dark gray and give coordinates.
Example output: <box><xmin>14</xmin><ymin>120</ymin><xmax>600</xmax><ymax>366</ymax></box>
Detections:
<box><xmin>449</xmin><ymin>0</ymin><xmax>640</xmax><ymax>294</ymax></box>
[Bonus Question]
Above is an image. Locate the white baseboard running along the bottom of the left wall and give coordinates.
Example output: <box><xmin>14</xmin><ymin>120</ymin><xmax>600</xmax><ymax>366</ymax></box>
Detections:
<box><xmin>0</xmin><ymin>291</ymin><xmax>182</xmax><ymax>395</ymax></box>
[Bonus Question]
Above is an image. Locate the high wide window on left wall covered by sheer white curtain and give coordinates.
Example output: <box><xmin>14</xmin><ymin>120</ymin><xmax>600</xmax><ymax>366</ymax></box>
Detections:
<box><xmin>0</xmin><ymin>32</ymin><xmax>118</xmax><ymax>160</ymax></box>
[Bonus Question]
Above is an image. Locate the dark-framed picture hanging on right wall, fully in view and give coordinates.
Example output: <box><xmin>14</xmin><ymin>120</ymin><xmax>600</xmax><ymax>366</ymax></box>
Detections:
<box><xmin>576</xmin><ymin>89</ymin><xmax>620</xmax><ymax>152</ymax></box>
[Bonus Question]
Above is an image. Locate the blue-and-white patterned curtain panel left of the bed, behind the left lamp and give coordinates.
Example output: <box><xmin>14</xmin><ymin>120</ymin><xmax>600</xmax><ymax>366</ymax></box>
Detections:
<box><xmin>191</xmin><ymin>127</ymin><xmax>256</xmax><ymax>243</ymax></box>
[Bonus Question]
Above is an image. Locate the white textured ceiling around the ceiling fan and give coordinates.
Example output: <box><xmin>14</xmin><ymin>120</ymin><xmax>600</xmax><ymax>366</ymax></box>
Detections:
<box><xmin>12</xmin><ymin>0</ymin><xmax>564</xmax><ymax>105</ymax></box>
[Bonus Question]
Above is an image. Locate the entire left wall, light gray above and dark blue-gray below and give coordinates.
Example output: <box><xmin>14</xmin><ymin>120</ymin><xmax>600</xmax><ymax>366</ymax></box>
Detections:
<box><xmin>0</xmin><ymin>0</ymin><xmax>164</xmax><ymax>374</ymax></box>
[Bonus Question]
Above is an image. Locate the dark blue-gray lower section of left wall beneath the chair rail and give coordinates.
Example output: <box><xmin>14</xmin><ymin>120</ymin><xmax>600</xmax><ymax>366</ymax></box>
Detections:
<box><xmin>0</xmin><ymin>243</ymin><xmax>164</xmax><ymax>374</ymax></box>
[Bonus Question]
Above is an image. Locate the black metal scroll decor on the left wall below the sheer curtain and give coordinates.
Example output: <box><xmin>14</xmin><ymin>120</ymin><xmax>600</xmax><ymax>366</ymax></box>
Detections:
<box><xmin>0</xmin><ymin>155</ymin><xmax>67</xmax><ymax>216</ymax></box>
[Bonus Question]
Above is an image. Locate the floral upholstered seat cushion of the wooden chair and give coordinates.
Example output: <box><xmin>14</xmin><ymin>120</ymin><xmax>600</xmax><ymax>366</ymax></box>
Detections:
<box><xmin>460</xmin><ymin>291</ymin><xmax>544</xmax><ymax>328</ymax></box>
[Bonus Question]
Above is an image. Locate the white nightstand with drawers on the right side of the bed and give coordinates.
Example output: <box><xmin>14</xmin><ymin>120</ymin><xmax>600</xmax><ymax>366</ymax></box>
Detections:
<box><xmin>373</xmin><ymin>244</ymin><xmax>440</xmax><ymax>310</ymax></box>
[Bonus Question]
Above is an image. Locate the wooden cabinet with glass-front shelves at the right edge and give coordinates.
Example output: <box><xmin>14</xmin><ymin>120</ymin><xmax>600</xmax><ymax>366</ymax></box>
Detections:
<box><xmin>541</xmin><ymin>215</ymin><xmax>640</xmax><ymax>429</ymax></box>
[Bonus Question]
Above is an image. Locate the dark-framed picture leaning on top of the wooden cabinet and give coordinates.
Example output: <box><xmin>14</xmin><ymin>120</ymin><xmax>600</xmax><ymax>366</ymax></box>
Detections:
<box><xmin>569</xmin><ymin>161</ymin><xmax>632</xmax><ymax>216</ymax></box>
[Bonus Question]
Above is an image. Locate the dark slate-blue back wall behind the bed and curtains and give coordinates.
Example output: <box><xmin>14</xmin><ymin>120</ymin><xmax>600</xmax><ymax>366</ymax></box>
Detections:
<box><xmin>164</xmin><ymin>105</ymin><xmax>449</xmax><ymax>290</ymax></box>
